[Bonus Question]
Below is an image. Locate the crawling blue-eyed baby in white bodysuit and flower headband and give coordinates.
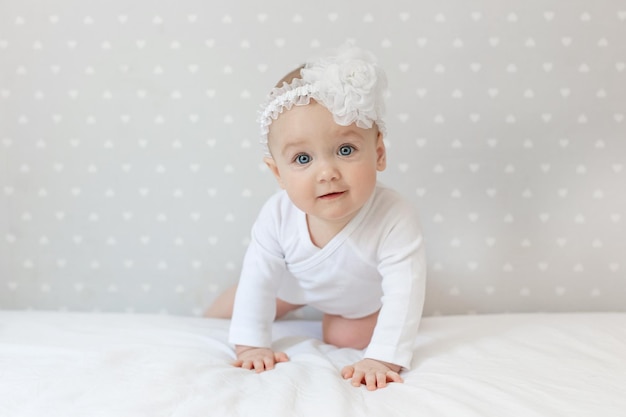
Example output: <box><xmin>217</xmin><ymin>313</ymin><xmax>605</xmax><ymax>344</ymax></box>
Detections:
<box><xmin>207</xmin><ymin>46</ymin><xmax>426</xmax><ymax>390</ymax></box>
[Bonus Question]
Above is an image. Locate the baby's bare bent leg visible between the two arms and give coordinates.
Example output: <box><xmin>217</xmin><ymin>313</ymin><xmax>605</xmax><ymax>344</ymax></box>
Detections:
<box><xmin>322</xmin><ymin>312</ymin><xmax>378</xmax><ymax>349</ymax></box>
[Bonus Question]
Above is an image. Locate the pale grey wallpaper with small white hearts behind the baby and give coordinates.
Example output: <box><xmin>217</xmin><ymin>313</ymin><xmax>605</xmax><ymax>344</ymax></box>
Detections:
<box><xmin>0</xmin><ymin>0</ymin><xmax>626</xmax><ymax>315</ymax></box>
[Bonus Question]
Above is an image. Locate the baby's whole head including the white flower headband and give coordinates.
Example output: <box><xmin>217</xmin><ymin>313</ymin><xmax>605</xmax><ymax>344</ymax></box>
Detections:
<box><xmin>259</xmin><ymin>47</ymin><xmax>386</xmax><ymax>226</ymax></box>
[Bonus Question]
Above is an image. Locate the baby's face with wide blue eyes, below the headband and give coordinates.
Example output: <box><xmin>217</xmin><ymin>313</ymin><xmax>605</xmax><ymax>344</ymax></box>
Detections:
<box><xmin>265</xmin><ymin>100</ymin><xmax>386</xmax><ymax>229</ymax></box>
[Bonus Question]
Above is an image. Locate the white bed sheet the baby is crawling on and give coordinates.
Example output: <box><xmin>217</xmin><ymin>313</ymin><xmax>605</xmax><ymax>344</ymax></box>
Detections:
<box><xmin>0</xmin><ymin>312</ymin><xmax>626</xmax><ymax>417</ymax></box>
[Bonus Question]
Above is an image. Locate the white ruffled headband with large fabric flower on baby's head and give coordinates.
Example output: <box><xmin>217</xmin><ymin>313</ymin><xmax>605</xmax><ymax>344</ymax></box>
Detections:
<box><xmin>258</xmin><ymin>46</ymin><xmax>387</xmax><ymax>155</ymax></box>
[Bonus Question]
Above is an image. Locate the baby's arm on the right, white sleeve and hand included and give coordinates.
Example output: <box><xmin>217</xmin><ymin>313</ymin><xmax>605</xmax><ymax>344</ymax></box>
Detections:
<box><xmin>342</xmin><ymin>192</ymin><xmax>426</xmax><ymax>390</ymax></box>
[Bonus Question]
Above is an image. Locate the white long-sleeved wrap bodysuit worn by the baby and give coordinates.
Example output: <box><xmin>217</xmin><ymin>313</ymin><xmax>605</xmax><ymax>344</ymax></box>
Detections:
<box><xmin>230</xmin><ymin>184</ymin><xmax>426</xmax><ymax>369</ymax></box>
